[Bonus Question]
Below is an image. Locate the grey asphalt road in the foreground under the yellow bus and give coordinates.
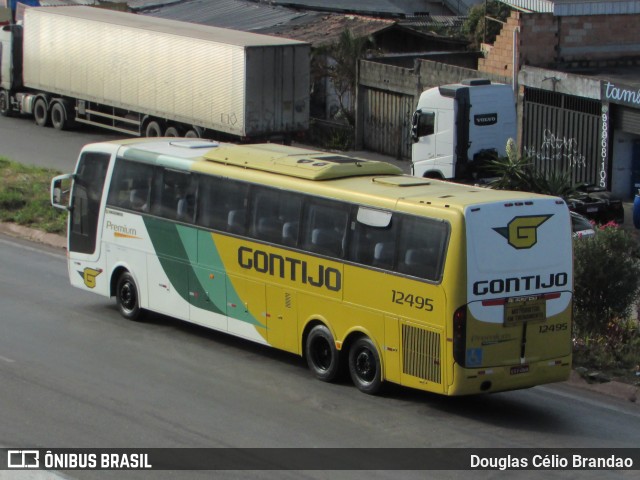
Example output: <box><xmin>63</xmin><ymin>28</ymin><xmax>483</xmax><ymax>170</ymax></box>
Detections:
<box><xmin>0</xmin><ymin>236</ymin><xmax>640</xmax><ymax>478</ymax></box>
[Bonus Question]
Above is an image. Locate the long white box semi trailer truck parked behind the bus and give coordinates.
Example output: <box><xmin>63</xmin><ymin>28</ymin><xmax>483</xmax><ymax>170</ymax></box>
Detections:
<box><xmin>0</xmin><ymin>6</ymin><xmax>310</xmax><ymax>141</ymax></box>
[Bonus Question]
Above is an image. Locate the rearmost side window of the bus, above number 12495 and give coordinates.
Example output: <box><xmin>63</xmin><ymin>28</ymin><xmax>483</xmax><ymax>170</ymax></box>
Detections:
<box><xmin>397</xmin><ymin>217</ymin><xmax>448</xmax><ymax>281</ymax></box>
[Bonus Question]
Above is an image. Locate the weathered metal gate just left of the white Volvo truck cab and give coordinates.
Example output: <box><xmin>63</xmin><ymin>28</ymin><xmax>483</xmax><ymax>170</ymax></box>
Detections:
<box><xmin>362</xmin><ymin>88</ymin><xmax>415</xmax><ymax>159</ymax></box>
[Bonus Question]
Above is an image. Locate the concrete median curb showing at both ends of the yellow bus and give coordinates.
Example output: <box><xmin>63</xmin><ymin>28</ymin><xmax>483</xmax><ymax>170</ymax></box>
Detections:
<box><xmin>0</xmin><ymin>222</ymin><xmax>640</xmax><ymax>404</ymax></box>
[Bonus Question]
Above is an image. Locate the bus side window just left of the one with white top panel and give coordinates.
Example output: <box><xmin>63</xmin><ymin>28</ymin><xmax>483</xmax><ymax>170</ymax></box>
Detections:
<box><xmin>303</xmin><ymin>201</ymin><xmax>349</xmax><ymax>258</ymax></box>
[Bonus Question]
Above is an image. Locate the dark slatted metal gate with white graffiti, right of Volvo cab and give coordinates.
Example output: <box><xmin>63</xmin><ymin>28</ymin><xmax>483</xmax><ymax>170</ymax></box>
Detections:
<box><xmin>522</xmin><ymin>88</ymin><xmax>601</xmax><ymax>184</ymax></box>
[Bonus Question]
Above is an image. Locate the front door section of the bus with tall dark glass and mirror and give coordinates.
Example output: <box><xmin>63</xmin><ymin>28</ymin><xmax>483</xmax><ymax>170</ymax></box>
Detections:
<box><xmin>52</xmin><ymin>151</ymin><xmax>111</xmax><ymax>295</ymax></box>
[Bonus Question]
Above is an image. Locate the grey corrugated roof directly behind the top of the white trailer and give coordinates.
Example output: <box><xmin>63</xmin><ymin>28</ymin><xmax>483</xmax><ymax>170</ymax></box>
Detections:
<box><xmin>143</xmin><ymin>0</ymin><xmax>306</xmax><ymax>31</ymax></box>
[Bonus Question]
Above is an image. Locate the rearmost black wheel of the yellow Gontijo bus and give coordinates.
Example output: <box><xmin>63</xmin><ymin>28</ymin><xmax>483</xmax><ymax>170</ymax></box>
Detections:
<box><xmin>349</xmin><ymin>337</ymin><xmax>383</xmax><ymax>395</ymax></box>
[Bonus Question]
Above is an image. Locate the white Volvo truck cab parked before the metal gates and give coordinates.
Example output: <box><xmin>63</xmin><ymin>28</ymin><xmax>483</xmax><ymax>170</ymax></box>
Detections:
<box><xmin>411</xmin><ymin>79</ymin><xmax>517</xmax><ymax>180</ymax></box>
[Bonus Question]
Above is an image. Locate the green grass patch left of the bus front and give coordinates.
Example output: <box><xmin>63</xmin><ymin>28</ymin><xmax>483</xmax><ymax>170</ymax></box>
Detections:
<box><xmin>0</xmin><ymin>157</ymin><xmax>67</xmax><ymax>234</ymax></box>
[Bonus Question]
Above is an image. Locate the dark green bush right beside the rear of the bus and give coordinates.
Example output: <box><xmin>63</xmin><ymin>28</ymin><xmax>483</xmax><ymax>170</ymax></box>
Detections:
<box><xmin>574</xmin><ymin>226</ymin><xmax>640</xmax><ymax>343</ymax></box>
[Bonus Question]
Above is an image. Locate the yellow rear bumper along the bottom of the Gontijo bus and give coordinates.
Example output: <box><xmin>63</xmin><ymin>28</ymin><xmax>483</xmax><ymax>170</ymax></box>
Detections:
<box><xmin>447</xmin><ymin>355</ymin><xmax>571</xmax><ymax>395</ymax></box>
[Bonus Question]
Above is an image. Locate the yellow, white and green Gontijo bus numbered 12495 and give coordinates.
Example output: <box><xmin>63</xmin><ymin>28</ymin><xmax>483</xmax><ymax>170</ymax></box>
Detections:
<box><xmin>51</xmin><ymin>138</ymin><xmax>572</xmax><ymax>395</ymax></box>
